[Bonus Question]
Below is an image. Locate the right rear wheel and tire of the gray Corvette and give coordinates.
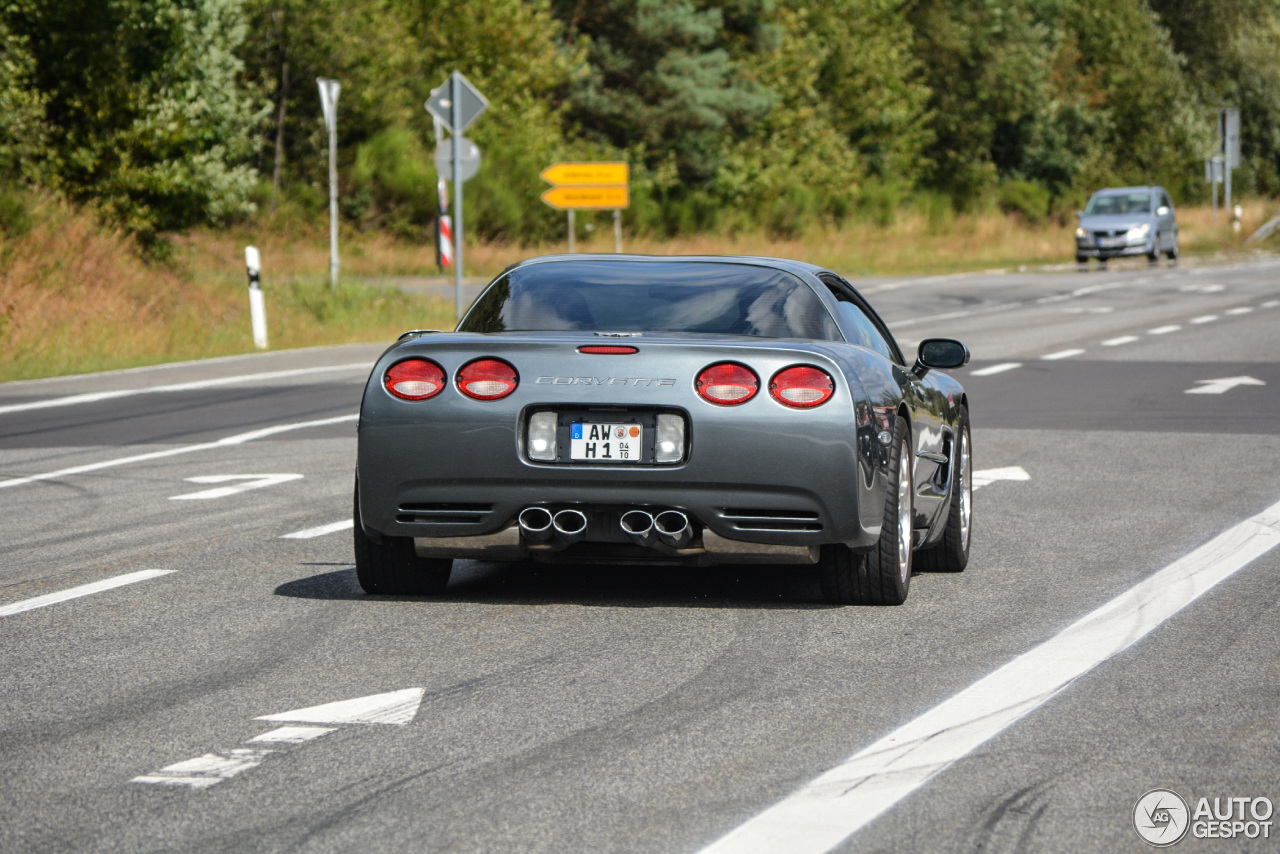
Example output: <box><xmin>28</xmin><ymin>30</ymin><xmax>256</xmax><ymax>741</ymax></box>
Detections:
<box><xmin>818</xmin><ymin>417</ymin><xmax>914</xmax><ymax>604</ymax></box>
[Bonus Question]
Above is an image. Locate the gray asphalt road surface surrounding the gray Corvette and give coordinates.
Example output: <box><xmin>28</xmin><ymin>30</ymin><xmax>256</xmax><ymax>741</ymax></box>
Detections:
<box><xmin>0</xmin><ymin>257</ymin><xmax>1280</xmax><ymax>853</ymax></box>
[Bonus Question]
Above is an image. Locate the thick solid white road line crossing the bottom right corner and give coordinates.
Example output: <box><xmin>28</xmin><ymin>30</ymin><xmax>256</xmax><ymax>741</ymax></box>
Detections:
<box><xmin>701</xmin><ymin>494</ymin><xmax>1280</xmax><ymax>854</ymax></box>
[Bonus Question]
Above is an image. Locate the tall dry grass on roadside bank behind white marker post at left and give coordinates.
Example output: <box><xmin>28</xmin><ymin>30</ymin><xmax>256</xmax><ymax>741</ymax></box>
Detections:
<box><xmin>0</xmin><ymin>198</ymin><xmax>452</xmax><ymax>380</ymax></box>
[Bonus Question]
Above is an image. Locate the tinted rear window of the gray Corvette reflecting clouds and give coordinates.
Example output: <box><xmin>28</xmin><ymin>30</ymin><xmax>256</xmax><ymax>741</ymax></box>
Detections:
<box><xmin>458</xmin><ymin>261</ymin><xmax>840</xmax><ymax>339</ymax></box>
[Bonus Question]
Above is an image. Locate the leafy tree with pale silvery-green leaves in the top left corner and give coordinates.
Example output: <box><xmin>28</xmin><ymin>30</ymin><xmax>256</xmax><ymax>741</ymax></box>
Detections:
<box><xmin>8</xmin><ymin>0</ymin><xmax>261</xmax><ymax>233</ymax></box>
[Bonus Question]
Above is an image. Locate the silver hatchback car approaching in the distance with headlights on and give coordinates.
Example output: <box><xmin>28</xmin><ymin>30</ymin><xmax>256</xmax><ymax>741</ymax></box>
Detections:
<box><xmin>1075</xmin><ymin>187</ymin><xmax>1178</xmax><ymax>264</ymax></box>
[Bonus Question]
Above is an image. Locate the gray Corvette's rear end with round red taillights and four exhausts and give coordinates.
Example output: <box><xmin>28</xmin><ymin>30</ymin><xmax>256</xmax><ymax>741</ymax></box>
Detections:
<box><xmin>357</xmin><ymin>332</ymin><xmax>876</xmax><ymax>562</ymax></box>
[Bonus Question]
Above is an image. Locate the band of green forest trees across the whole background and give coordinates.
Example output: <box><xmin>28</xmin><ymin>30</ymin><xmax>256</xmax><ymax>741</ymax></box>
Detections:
<box><xmin>0</xmin><ymin>0</ymin><xmax>1280</xmax><ymax>243</ymax></box>
